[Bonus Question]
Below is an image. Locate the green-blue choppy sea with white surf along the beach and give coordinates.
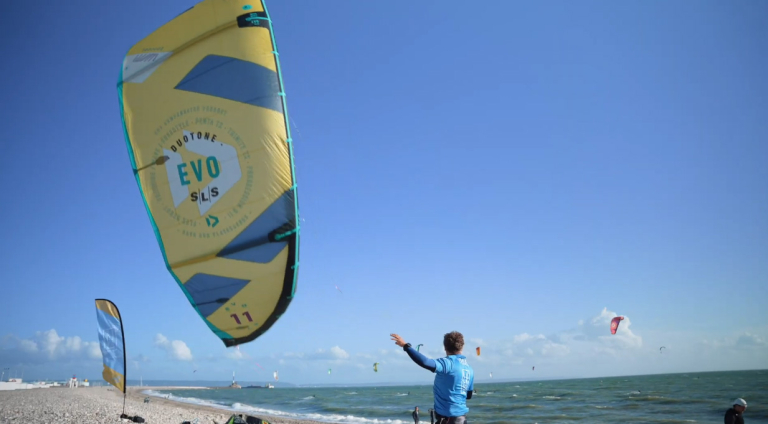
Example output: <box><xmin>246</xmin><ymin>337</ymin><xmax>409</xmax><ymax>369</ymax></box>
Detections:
<box><xmin>136</xmin><ymin>370</ymin><xmax>768</xmax><ymax>424</ymax></box>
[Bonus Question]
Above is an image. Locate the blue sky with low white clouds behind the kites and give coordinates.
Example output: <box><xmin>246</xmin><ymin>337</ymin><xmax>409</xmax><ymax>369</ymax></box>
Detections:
<box><xmin>0</xmin><ymin>0</ymin><xmax>768</xmax><ymax>383</ymax></box>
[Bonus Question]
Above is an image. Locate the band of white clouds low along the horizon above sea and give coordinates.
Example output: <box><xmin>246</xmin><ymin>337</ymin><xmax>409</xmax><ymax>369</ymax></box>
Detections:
<box><xmin>0</xmin><ymin>308</ymin><xmax>768</xmax><ymax>384</ymax></box>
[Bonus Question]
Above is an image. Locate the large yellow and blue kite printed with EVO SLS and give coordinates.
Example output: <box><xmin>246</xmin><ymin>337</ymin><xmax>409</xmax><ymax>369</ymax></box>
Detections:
<box><xmin>117</xmin><ymin>0</ymin><xmax>299</xmax><ymax>347</ymax></box>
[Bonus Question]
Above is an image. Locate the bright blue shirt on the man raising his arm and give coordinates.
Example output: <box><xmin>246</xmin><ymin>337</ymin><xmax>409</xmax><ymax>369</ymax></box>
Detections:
<box><xmin>432</xmin><ymin>355</ymin><xmax>475</xmax><ymax>417</ymax></box>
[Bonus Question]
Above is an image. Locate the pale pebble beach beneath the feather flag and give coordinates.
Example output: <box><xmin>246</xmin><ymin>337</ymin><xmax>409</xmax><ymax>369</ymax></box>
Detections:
<box><xmin>0</xmin><ymin>387</ymin><xmax>321</xmax><ymax>424</ymax></box>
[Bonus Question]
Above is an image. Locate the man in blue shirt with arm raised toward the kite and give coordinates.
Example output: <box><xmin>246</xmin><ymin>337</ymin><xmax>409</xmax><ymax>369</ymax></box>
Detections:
<box><xmin>390</xmin><ymin>331</ymin><xmax>475</xmax><ymax>424</ymax></box>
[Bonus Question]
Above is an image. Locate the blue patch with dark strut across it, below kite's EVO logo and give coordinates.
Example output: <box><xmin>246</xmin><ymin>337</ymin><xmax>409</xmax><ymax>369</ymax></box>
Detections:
<box><xmin>217</xmin><ymin>190</ymin><xmax>294</xmax><ymax>264</ymax></box>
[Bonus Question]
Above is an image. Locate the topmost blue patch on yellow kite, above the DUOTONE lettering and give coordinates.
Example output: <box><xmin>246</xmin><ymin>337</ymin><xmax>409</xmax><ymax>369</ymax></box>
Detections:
<box><xmin>175</xmin><ymin>54</ymin><xmax>283</xmax><ymax>113</ymax></box>
